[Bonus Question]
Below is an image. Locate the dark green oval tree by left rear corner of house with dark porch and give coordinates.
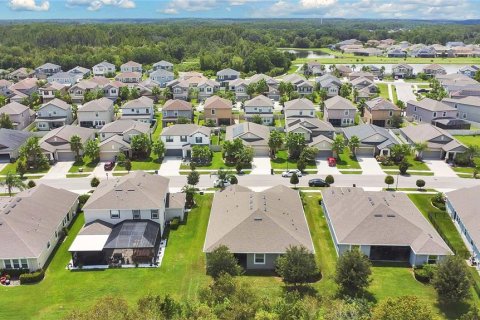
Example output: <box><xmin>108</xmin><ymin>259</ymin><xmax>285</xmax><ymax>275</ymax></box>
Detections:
<box><xmin>335</xmin><ymin>250</ymin><xmax>372</xmax><ymax>295</ymax></box>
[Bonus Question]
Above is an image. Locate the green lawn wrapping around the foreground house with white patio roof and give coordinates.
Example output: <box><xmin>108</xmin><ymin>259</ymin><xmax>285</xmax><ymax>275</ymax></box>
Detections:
<box><xmin>0</xmin><ymin>195</ymin><xmax>213</xmax><ymax>320</ymax></box>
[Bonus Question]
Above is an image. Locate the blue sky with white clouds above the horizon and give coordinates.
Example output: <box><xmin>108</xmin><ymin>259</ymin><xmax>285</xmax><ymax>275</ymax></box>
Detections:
<box><xmin>0</xmin><ymin>0</ymin><xmax>480</xmax><ymax>20</ymax></box>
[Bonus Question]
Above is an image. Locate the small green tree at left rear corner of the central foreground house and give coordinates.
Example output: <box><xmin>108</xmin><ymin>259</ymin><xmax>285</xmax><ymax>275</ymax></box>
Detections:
<box><xmin>207</xmin><ymin>245</ymin><xmax>242</xmax><ymax>279</ymax></box>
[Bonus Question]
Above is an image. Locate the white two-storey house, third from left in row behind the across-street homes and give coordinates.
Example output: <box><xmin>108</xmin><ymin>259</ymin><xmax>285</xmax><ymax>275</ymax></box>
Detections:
<box><xmin>77</xmin><ymin>98</ymin><xmax>115</xmax><ymax>129</ymax></box>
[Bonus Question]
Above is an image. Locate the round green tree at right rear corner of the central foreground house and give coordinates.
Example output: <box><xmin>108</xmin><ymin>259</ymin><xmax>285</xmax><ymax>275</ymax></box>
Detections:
<box><xmin>276</xmin><ymin>246</ymin><xmax>319</xmax><ymax>286</ymax></box>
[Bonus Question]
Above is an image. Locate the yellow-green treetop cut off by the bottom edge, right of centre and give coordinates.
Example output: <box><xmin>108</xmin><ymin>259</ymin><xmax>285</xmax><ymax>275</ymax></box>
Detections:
<box><xmin>372</xmin><ymin>296</ymin><xmax>436</xmax><ymax>320</ymax></box>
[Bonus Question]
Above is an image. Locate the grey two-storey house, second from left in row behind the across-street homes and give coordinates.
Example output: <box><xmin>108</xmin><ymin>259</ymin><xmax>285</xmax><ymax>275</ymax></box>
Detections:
<box><xmin>35</xmin><ymin>98</ymin><xmax>73</xmax><ymax>131</ymax></box>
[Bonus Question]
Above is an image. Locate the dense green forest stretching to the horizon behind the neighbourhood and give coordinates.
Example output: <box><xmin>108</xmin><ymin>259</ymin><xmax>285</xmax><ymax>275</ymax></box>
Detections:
<box><xmin>0</xmin><ymin>19</ymin><xmax>480</xmax><ymax>76</ymax></box>
